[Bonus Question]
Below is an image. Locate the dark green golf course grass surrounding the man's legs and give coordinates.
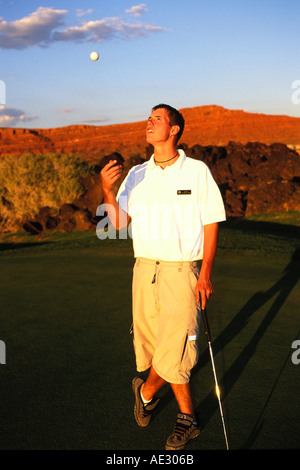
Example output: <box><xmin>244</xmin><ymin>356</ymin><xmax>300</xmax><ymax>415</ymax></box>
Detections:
<box><xmin>0</xmin><ymin>213</ymin><xmax>300</xmax><ymax>451</ymax></box>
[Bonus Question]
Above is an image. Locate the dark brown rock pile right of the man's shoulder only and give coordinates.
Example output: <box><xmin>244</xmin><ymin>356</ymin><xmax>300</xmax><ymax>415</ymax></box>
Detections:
<box><xmin>185</xmin><ymin>142</ymin><xmax>300</xmax><ymax>217</ymax></box>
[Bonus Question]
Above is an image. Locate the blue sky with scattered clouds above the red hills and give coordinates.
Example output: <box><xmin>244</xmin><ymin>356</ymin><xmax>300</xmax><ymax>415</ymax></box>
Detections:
<box><xmin>0</xmin><ymin>0</ymin><xmax>300</xmax><ymax>128</ymax></box>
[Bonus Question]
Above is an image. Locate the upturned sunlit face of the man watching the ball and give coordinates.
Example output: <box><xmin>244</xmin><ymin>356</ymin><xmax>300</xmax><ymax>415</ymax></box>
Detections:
<box><xmin>146</xmin><ymin>108</ymin><xmax>172</xmax><ymax>144</ymax></box>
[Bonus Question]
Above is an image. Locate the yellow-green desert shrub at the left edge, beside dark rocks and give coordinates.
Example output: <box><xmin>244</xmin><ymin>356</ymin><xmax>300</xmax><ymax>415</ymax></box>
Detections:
<box><xmin>0</xmin><ymin>153</ymin><xmax>89</xmax><ymax>229</ymax></box>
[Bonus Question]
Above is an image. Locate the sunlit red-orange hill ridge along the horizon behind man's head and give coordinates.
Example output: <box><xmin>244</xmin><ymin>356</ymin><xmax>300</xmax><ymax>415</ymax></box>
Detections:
<box><xmin>0</xmin><ymin>106</ymin><xmax>300</xmax><ymax>162</ymax></box>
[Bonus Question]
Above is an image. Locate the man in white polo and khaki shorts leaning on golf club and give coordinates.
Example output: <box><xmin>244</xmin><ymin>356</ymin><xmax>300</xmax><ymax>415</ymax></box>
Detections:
<box><xmin>101</xmin><ymin>104</ymin><xmax>225</xmax><ymax>450</ymax></box>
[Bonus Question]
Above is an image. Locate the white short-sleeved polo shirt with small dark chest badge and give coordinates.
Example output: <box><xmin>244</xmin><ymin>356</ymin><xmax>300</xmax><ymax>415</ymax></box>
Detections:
<box><xmin>117</xmin><ymin>150</ymin><xmax>226</xmax><ymax>261</ymax></box>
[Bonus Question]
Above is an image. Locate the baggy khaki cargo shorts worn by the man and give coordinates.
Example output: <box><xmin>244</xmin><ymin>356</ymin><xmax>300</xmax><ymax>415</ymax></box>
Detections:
<box><xmin>132</xmin><ymin>258</ymin><xmax>200</xmax><ymax>384</ymax></box>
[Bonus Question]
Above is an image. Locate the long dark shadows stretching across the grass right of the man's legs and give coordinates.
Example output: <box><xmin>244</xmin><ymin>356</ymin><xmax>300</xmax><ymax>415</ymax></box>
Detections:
<box><xmin>193</xmin><ymin>248</ymin><xmax>300</xmax><ymax>448</ymax></box>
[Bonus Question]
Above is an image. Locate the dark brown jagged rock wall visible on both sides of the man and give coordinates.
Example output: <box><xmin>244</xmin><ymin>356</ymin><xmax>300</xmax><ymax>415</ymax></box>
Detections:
<box><xmin>22</xmin><ymin>142</ymin><xmax>300</xmax><ymax>234</ymax></box>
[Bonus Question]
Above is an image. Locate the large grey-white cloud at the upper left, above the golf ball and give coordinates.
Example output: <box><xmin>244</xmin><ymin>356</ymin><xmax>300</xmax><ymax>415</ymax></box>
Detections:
<box><xmin>0</xmin><ymin>4</ymin><xmax>163</xmax><ymax>49</ymax></box>
